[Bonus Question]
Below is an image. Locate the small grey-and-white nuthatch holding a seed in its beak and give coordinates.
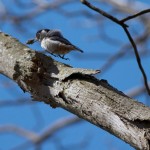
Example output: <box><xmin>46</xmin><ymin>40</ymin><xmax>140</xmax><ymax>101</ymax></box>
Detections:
<box><xmin>27</xmin><ymin>29</ymin><xmax>83</xmax><ymax>59</ymax></box>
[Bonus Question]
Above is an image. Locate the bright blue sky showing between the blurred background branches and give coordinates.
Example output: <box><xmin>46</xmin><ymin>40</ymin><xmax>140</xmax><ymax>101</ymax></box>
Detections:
<box><xmin>0</xmin><ymin>0</ymin><xmax>150</xmax><ymax>150</ymax></box>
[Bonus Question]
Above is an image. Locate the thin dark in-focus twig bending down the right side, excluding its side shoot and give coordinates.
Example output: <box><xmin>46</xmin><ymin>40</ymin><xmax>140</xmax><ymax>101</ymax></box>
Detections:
<box><xmin>81</xmin><ymin>0</ymin><xmax>150</xmax><ymax>95</ymax></box>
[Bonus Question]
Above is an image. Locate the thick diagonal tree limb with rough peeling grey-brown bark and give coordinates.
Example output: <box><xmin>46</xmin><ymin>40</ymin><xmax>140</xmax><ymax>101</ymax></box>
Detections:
<box><xmin>0</xmin><ymin>32</ymin><xmax>150</xmax><ymax>150</ymax></box>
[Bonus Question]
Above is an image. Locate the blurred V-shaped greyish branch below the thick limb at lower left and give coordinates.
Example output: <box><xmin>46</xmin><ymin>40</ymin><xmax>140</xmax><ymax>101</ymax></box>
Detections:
<box><xmin>9</xmin><ymin>116</ymin><xmax>83</xmax><ymax>150</ymax></box>
